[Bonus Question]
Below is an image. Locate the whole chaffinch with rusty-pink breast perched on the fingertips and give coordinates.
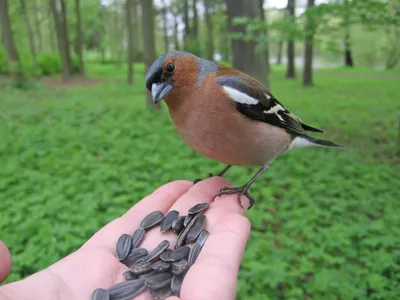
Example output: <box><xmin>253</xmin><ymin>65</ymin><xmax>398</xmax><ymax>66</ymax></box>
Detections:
<box><xmin>146</xmin><ymin>51</ymin><xmax>341</xmax><ymax>207</ymax></box>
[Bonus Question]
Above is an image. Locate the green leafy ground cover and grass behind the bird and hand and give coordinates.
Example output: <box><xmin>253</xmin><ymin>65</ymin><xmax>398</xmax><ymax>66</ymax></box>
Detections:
<box><xmin>0</xmin><ymin>65</ymin><xmax>400</xmax><ymax>300</ymax></box>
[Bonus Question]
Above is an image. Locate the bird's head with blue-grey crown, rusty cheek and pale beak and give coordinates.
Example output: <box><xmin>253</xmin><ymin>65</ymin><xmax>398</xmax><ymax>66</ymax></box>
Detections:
<box><xmin>146</xmin><ymin>51</ymin><xmax>217</xmax><ymax>103</ymax></box>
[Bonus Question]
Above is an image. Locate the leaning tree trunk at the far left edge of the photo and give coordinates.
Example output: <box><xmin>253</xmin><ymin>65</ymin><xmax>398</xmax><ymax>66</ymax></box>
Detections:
<box><xmin>0</xmin><ymin>0</ymin><xmax>24</xmax><ymax>84</ymax></box>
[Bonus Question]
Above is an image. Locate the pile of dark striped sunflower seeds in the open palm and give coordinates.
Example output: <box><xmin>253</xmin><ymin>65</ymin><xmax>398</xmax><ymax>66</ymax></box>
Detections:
<box><xmin>91</xmin><ymin>203</ymin><xmax>209</xmax><ymax>300</ymax></box>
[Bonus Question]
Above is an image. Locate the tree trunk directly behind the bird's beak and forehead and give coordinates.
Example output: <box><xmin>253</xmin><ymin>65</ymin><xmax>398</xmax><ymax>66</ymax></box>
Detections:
<box><xmin>141</xmin><ymin>0</ymin><xmax>161</xmax><ymax>109</ymax></box>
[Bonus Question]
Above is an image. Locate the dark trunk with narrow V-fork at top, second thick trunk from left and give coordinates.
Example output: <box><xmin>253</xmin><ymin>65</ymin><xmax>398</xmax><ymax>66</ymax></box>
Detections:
<box><xmin>50</xmin><ymin>0</ymin><xmax>72</xmax><ymax>81</ymax></box>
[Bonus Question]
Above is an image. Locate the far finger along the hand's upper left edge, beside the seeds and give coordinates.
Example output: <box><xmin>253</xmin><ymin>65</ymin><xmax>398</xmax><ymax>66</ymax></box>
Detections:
<box><xmin>82</xmin><ymin>181</ymin><xmax>193</xmax><ymax>253</ymax></box>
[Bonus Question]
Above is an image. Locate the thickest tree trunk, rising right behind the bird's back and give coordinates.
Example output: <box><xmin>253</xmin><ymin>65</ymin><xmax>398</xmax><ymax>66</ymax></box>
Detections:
<box><xmin>225</xmin><ymin>0</ymin><xmax>268</xmax><ymax>85</ymax></box>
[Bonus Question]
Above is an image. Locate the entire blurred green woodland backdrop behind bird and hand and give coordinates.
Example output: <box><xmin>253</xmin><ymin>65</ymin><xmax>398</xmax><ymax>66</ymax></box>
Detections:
<box><xmin>0</xmin><ymin>0</ymin><xmax>400</xmax><ymax>300</ymax></box>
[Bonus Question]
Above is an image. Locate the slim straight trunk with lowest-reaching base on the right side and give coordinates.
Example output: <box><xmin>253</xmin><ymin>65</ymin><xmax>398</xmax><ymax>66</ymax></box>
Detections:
<box><xmin>303</xmin><ymin>0</ymin><xmax>315</xmax><ymax>86</ymax></box>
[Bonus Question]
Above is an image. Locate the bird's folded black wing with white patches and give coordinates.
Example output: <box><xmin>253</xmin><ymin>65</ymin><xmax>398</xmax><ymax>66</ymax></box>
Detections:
<box><xmin>216</xmin><ymin>65</ymin><xmax>321</xmax><ymax>135</ymax></box>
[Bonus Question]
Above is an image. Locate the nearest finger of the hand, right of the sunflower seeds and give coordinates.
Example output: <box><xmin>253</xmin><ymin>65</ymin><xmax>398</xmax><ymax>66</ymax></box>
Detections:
<box><xmin>181</xmin><ymin>213</ymin><xmax>250</xmax><ymax>300</ymax></box>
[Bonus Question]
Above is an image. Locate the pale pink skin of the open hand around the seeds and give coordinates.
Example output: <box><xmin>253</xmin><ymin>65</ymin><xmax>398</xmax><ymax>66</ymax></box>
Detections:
<box><xmin>0</xmin><ymin>177</ymin><xmax>250</xmax><ymax>300</ymax></box>
